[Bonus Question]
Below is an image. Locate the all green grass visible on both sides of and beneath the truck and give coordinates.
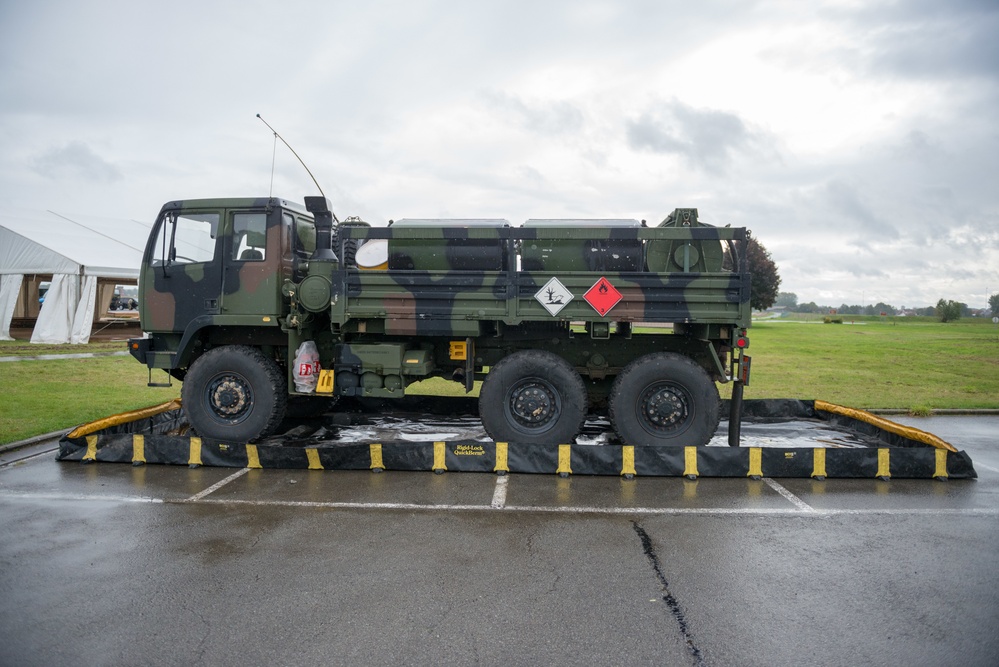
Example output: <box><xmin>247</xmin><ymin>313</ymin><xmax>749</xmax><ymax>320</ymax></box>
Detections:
<box><xmin>0</xmin><ymin>316</ymin><xmax>999</xmax><ymax>444</ymax></box>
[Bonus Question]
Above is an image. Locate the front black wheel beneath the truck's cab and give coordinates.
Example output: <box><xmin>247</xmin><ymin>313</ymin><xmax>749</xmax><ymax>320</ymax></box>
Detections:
<box><xmin>181</xmin><ymin>345</ymin><xmax>287</xmax><ymax>443</ymax></box>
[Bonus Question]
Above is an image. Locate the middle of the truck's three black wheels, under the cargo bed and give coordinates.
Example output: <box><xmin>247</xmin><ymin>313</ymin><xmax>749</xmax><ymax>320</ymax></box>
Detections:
<box><xmin>479</xmin><ymin>350</ymin><xmax>587</xmax><ymax>445</ymax></box>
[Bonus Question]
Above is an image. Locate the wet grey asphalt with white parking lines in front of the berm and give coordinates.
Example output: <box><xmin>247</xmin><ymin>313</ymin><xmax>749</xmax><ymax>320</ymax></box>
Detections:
<box><xmin>0</xmin><ymin>416</ymin><xmax>999</xmax><ymax>666</ymax></box>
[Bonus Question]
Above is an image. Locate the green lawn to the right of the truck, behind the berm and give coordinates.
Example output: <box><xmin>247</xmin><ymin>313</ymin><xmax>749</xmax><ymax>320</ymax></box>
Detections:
<box><xmin>745</xmin><ymin>316</ymin><xmax>999</xmax><ymax>412</ymax></box>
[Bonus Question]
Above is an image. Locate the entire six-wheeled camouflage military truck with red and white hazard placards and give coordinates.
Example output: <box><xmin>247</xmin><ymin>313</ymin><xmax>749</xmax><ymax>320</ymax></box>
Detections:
<box><xmin>129</xmin><ymin>196</ymin><xmax>750</xmax><ymax>446</ymax></box>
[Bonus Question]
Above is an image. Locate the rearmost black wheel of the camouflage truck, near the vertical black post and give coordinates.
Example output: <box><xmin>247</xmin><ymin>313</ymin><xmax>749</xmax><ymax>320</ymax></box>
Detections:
<box><xmin>609</xmin><ymin>352</ymin><xmax>721</xmax><ymax>446</ymax></box>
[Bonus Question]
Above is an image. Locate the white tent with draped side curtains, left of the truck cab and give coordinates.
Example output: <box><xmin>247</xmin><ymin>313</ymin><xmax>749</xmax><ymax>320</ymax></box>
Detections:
<box><xmin>0</xmin><ymin>210</ymin><xmax>151</xmax><ymax>343</ymax></box>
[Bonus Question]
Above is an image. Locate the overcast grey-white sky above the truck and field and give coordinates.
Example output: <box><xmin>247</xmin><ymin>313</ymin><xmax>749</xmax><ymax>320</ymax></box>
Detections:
<box><xmin>0</xmin><ymin>0</ymin><xmax>999</xmax><ymax>307</ymax></box>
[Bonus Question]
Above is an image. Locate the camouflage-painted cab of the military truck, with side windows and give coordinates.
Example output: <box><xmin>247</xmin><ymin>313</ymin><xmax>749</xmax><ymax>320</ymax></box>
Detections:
<box><xmin>133</xmin><ymin>198</ymin><xmax>315</xmax><ymax>379</ymax></box>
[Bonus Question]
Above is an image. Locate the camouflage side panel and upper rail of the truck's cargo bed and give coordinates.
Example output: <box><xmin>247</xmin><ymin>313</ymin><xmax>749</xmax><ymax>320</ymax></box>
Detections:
<box><xmin>333</xmin><ymin>222</ymin><xmax>750</xmax><ymax>328</ymax></box>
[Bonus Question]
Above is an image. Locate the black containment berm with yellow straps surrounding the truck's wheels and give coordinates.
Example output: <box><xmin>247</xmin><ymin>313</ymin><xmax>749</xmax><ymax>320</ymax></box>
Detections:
<box><xmin>58</xmin><ymin>400</ymin><xmax>977</xmax><ymax>479</ymax></box>
